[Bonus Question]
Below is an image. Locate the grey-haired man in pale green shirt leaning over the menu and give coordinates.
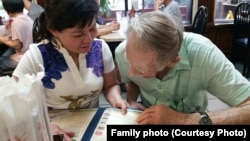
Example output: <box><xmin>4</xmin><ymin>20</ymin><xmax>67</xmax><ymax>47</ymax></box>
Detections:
<box><xmin>115</xmin><ymin>11</ymin><xmax>250</xmax><ymax>125</ymax></box>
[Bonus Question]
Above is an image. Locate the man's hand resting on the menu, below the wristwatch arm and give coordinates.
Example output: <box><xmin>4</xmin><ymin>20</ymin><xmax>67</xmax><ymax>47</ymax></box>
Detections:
<box><xmin>137</xmin><ymin>104</ymin><xmax>188</xmax><ymax>124</ymax></box>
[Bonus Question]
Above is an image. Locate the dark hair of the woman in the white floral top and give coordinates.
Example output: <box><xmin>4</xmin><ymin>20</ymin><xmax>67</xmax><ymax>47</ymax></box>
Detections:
<box><xmin>35</xmin><ymin>0</ymin><xmax>98</xmax><ymax>41</ymax></box>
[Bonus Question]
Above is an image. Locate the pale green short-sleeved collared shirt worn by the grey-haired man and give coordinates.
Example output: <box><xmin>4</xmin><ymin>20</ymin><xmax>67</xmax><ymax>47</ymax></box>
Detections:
<box><xmin>115</xmin><ymin>32</ymin><xmax>250</xmax><ymax>113</ymax></box>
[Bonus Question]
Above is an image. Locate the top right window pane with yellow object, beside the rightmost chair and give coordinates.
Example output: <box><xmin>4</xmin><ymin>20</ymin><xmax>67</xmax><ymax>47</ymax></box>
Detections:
<box><xmin>215</xmin><ymin>0</ymin><xmax>250</xmax><ymax>24</ymax></box>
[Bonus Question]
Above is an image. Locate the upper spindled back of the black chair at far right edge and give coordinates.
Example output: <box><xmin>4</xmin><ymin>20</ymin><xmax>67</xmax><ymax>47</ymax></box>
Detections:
<box><xmin>233</xmin><ymin>2</ymin><xmax>250</xmax><ymax>42</ymax></box>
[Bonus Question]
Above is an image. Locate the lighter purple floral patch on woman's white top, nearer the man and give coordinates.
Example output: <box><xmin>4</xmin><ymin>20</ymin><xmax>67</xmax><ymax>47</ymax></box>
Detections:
<box><xmin>86</xmin><ymin>40</ymin><xmax>104</xmax><ymax>77</ymax></box>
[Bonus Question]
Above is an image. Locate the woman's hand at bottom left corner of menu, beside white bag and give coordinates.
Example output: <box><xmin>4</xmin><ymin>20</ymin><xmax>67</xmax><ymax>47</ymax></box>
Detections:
<box><xmin>50</xmin><ymin>124</ymin><xmax>75</xmax><ymax>141</ymax></box>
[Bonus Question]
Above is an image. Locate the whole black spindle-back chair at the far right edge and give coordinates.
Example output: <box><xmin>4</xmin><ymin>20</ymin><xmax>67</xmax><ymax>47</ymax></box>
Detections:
<box><xmin>231</xmin><ymin>2</ymin><xmax>250</xmax><ymax>78</ymax></box>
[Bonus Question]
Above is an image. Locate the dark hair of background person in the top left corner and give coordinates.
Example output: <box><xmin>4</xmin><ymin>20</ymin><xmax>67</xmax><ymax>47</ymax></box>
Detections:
<box><xmin>2</xmin><ymin>0</ymin><xmax>24</xmax><ymax>14</ymax></box>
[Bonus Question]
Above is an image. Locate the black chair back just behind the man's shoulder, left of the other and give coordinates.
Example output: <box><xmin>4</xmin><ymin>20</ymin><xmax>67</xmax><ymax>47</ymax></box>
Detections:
<box><xmin>191</xmin><ymin>5</ymin><xmax>208</xmax><ymax>35</ymax></box>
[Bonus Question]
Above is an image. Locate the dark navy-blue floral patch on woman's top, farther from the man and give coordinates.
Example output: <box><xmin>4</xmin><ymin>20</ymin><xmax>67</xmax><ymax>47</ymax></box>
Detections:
<box><xmin>38</xmin><ymin>43</ymin><xmax>68</xmax><ymax>89</ymax></box>
